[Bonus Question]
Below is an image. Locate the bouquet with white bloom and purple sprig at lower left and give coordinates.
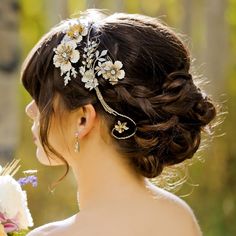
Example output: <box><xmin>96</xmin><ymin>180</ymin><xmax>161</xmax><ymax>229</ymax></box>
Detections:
<box><xmin>0</xmin><ymin>160</ymin><xmax>37</xmax><ymax>236</ymax></box>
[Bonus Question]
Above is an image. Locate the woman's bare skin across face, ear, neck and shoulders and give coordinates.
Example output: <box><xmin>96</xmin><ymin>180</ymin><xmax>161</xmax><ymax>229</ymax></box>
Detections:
<box><xmin>26</xmin><ymin>98</ymin><xmax>202</xmax><ymax>236</ymax></box>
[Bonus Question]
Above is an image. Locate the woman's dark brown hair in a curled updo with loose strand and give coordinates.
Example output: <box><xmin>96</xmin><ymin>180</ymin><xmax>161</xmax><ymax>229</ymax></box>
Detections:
<box><xmin>22</xmin><ymin>9</ymin><xmax>216</xmax><ymax>178</ymax></box>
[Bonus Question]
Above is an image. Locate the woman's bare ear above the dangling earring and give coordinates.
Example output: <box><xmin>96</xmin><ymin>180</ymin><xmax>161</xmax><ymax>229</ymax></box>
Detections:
<box><xmin>77</xmin><ymin>104</ymin><xmax>96</xmax><ymax>139</ymax></box>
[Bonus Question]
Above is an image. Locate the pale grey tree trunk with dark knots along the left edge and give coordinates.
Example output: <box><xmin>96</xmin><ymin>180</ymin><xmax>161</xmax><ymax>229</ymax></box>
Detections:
<box><xmin>0</xmin><ymin>0</ymin><xmax>20</xmax><ymax>163</ymax></box>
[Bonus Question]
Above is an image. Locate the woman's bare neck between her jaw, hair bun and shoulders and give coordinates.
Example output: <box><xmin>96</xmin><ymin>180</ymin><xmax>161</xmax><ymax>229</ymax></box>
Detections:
<box><xmin>72</xmin><ymin>134</ymin><xmax>146</xmax><ymax>211</ymax></box>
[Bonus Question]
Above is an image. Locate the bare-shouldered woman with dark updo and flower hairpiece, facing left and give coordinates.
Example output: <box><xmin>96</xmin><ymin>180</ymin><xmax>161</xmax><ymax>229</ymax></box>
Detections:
<box><xmin>22</xmin><ymin>10</ymin><xmax>215</xmax><ymax>236</ymax></box>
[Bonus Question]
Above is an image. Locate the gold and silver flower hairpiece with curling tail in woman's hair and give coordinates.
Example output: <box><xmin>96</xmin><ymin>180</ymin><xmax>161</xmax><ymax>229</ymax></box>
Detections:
<box><xmin>53</xmin><ymin>18</ymin><xmax>137</xmax><ymax>139</ymax></box>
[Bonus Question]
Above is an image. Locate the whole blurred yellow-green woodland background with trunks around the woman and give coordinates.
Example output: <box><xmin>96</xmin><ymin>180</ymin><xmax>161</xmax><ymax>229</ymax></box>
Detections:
<box><xmin>0</xmin><ymin>0</ymin><xmax>236</xmax><ymax>236</ymax></box>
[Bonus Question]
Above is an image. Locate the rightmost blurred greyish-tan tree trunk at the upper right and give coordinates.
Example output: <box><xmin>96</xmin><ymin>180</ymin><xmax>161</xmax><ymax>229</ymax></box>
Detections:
<box><xmin>205</xmin><ymin>0</ymin><xmax>228</xmax><ymax>98</ymax></box>
